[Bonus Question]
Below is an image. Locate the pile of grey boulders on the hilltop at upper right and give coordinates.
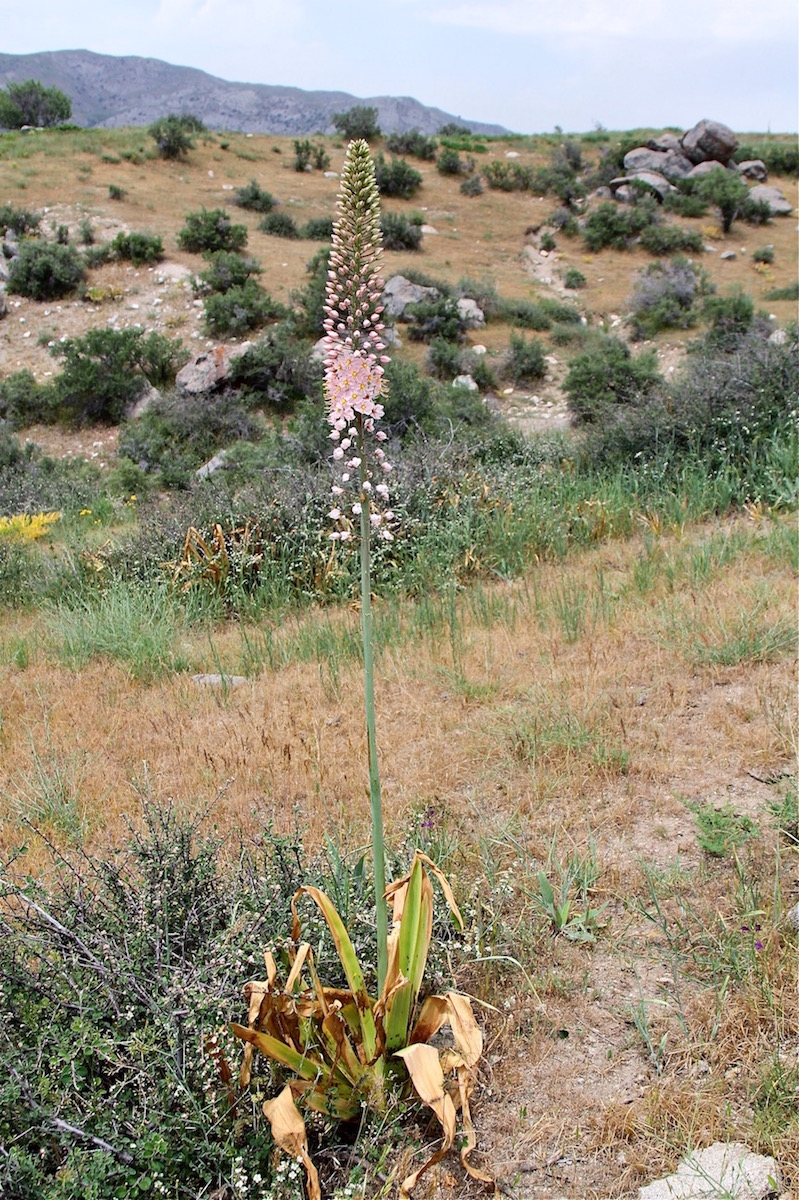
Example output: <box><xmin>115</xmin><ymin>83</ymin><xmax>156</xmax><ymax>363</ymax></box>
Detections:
<box><xmin>600</xmin><ymin>120</ymin><xmax>792</xmax><ymax>215</ymax></box>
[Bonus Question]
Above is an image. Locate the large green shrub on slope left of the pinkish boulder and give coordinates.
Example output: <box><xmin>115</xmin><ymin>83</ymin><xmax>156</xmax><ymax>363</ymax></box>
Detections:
<box><xmin>53</xmin><ymin>329</ymin><xmax>145</xmax><ymax>425</ymax></box>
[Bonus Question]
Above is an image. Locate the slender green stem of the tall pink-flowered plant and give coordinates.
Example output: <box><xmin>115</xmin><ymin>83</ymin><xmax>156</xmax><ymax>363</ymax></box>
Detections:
<box><xmin>358</xmin><ymin>416</ymin><xmax>389</xmax><ymax>996</ymax></box>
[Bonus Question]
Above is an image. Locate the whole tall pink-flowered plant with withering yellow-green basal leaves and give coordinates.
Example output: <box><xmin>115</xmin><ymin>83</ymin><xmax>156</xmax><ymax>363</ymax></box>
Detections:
<box><xmin>226</xmin><ymin>140</ymin><xmax>499</xmax><ymax>1200</ymax></box>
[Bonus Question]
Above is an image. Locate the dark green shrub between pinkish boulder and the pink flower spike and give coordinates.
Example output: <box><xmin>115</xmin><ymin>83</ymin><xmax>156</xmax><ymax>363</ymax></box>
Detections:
<box><xmin>229</xmin><ymin>325</ymin><xmax>324</xmax><ymax>412</ymax></box>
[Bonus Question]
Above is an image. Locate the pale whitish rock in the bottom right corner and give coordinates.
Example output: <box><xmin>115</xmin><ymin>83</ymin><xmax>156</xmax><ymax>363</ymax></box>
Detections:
<box><xmin>638</xmin><ymin>1141</ymin><xmax>780</xmax><ymax>1200</ymax></box>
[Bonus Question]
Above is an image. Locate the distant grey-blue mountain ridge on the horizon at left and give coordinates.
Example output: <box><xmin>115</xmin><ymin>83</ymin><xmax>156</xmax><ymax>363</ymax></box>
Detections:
<box><xmin>0</xmin><ymin>50</ymin><xmax>506</xmax><ymax>134</ymax></box>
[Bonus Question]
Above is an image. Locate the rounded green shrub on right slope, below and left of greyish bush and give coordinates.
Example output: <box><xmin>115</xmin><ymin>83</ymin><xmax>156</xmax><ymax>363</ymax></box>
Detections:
<box><xmin>564</xmin><ymin>337</ymin><xmax>660</xmax><ymax>425</ymax></box>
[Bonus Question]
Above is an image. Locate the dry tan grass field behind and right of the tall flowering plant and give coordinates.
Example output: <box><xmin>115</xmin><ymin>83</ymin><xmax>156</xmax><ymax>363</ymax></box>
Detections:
<box><xmin>0</xmin><ymin>521</ymin><xmax>799</xmax><ymax>1200</ymax></box>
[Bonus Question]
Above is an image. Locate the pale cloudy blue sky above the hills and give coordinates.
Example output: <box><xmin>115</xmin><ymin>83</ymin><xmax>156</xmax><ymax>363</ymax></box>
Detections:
<box><xmin>0</xmin><ymin>0</ymin><xmax>799</xmax><ymax>133</ymax></box>
